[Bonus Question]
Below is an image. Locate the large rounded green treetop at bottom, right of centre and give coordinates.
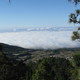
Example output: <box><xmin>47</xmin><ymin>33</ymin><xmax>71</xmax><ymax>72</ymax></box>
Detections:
<box><xmin>32</xmin><ymin>58</ymin><xmax>77</xmax><ymax>80</ymax></box>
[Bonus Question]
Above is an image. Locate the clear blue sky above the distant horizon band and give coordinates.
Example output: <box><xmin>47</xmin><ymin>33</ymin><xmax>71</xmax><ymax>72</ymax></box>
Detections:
<box><xmin>0</xmin><ymin>0</ymin><xmax>78</xmax><ymax>29</ymax></box>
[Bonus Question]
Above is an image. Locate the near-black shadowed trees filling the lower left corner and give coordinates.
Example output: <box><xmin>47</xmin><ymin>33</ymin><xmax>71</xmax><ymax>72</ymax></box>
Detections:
<box><xmin>0</xmin><ymin>53</ymin><xmax>26</xmax><ymax>80</ymax></box>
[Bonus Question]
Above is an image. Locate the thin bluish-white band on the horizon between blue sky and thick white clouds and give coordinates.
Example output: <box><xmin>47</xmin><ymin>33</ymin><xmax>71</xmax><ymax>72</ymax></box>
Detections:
<box><xmin>0</xmin><ymin>27</ymin><xmax>78</xmax><ymax>32</ymax></box>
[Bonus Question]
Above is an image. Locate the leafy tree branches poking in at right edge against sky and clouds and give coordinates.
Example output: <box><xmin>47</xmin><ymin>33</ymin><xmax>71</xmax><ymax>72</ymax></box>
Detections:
<box><xmin>68</xmin><ymin>0</ymin><xmax>80</xmax><ymax>40</ymax></box>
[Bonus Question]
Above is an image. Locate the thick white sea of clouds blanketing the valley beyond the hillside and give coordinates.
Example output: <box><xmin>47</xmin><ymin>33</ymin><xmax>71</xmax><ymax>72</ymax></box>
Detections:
<box><xmin>0</xmin><ymin>31</ymin><xmax>80</xmax><ymax>49</ymax></box>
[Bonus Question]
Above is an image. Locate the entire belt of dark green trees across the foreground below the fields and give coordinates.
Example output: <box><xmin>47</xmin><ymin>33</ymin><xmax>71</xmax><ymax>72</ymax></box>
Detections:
<box><xmin>0</xmin><ymin>50</ymin><xmax>77</xmax><ymax>80</ymax></box>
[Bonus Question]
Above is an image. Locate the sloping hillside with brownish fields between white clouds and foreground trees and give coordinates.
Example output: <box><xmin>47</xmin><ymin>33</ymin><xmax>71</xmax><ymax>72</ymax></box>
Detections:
<box><xmin>0</xmin><ymin>43</ymin><xmax>80</xmax><ymax>63</ymax></box>
